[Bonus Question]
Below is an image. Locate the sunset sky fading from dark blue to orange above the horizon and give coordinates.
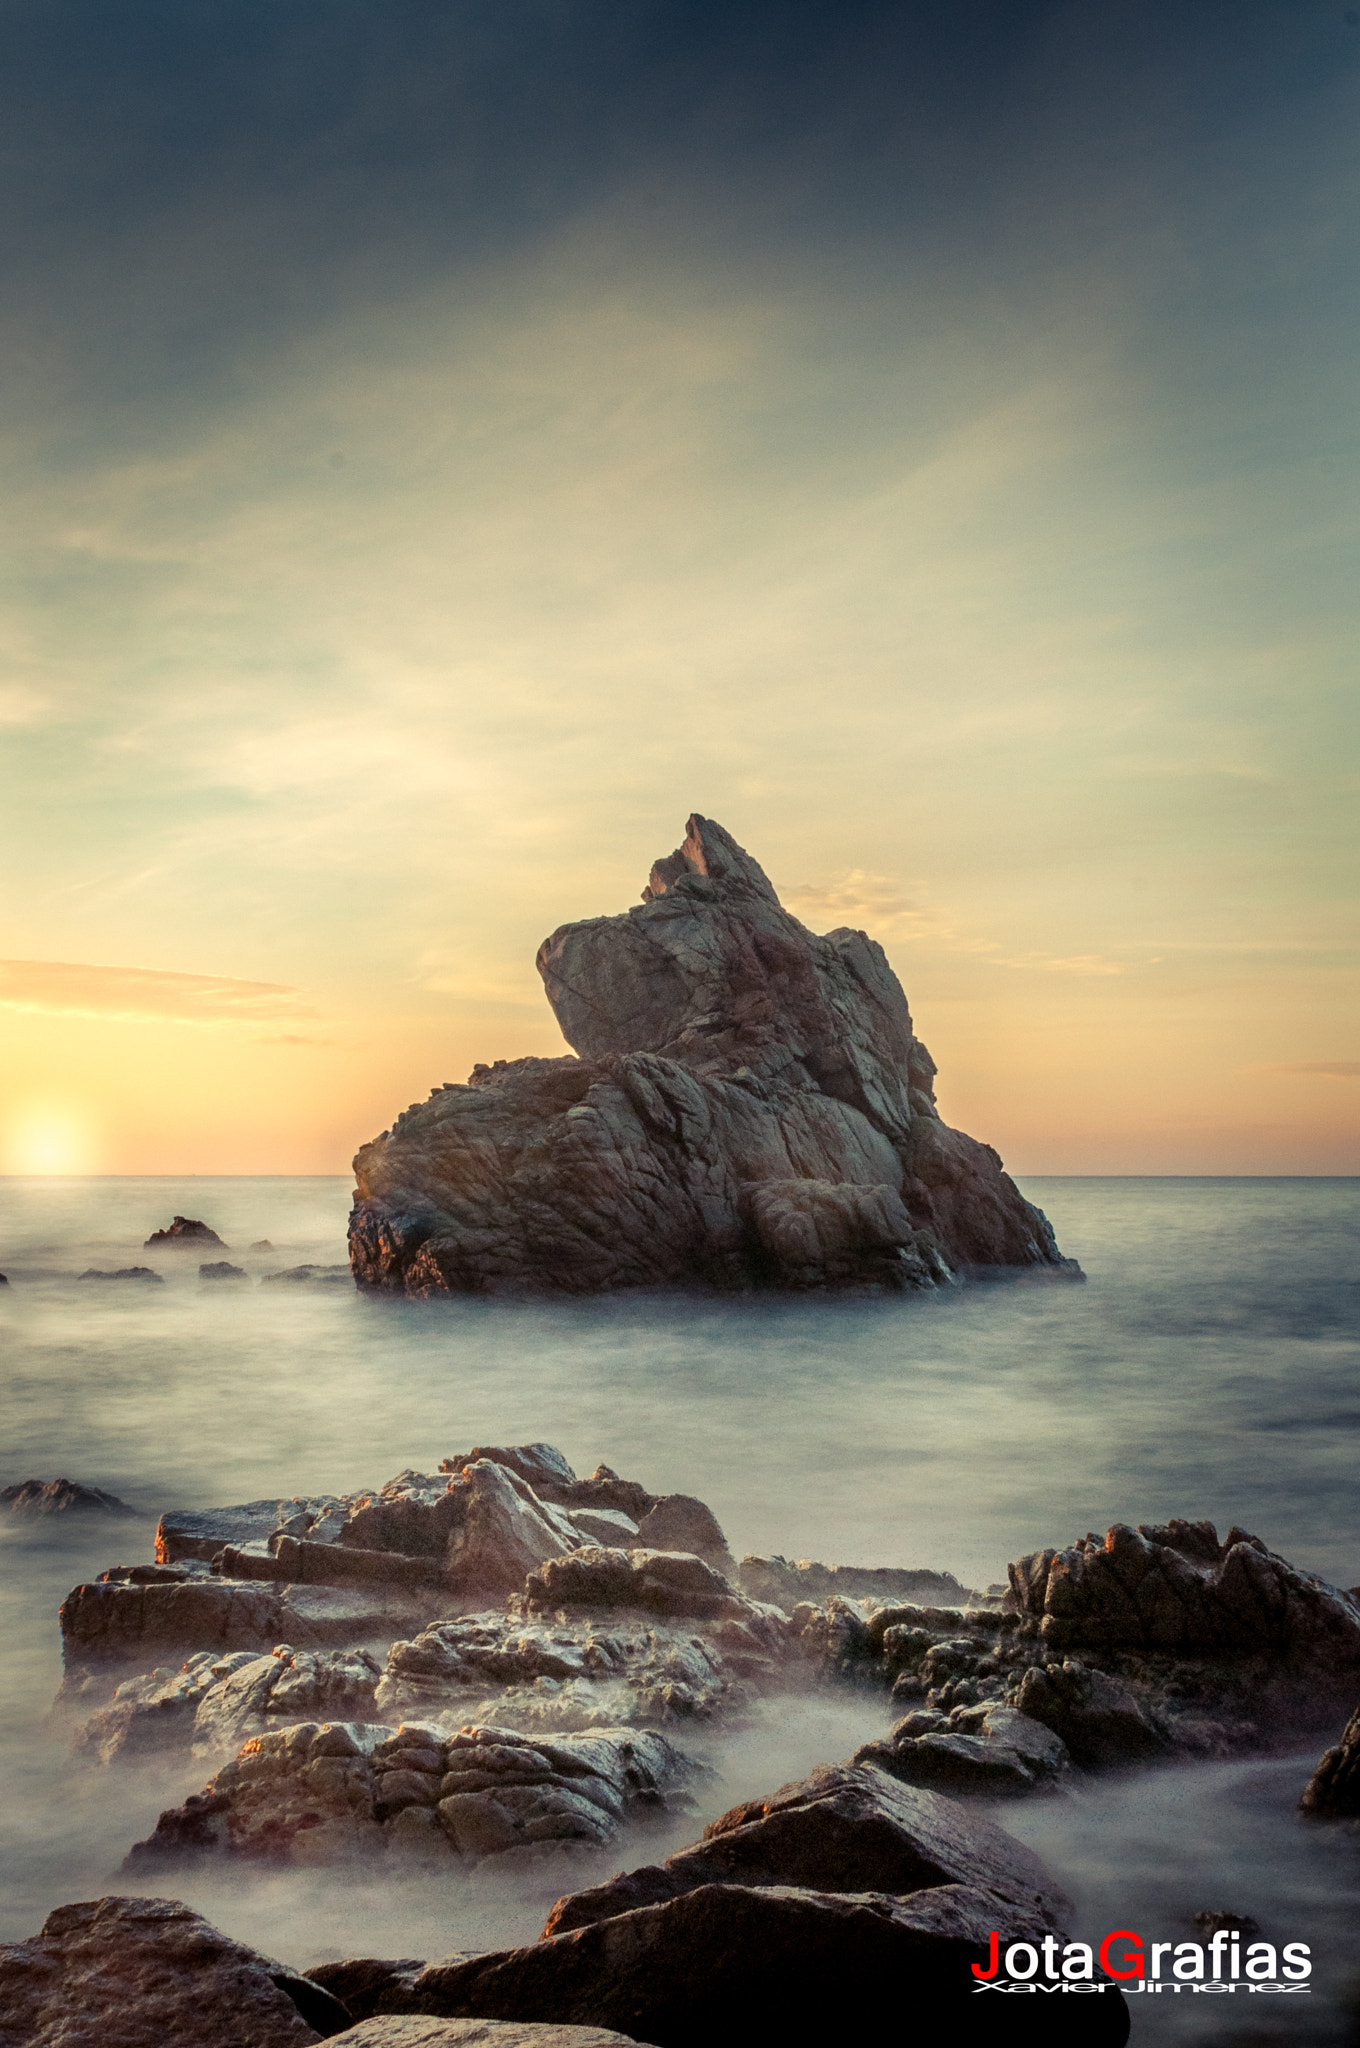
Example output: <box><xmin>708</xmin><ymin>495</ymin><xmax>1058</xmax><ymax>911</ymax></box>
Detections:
<box><xmin>0</xmin><ymin>0</ymin><xmax>1360</xmax><ymax>1176</ymax></box>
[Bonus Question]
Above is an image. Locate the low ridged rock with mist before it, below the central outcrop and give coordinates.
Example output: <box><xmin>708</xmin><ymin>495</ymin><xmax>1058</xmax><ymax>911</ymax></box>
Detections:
<box><xmin>125</xmin><ymin>1722</ymin><xmax>688</xmax><ymax>1876</ymax></box>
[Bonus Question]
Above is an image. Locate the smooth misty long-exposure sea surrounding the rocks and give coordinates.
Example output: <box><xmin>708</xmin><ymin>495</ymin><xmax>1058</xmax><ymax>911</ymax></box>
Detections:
<box><xmin>0</xmin><ymin>1178</ymin><xmax>1360</xmax><ymax>2048</ymax></box>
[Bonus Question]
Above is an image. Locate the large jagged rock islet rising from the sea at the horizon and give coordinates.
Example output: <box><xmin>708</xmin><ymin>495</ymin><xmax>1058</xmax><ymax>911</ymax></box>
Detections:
<box><xmin>350</xmin><ymin>817</ymin><xmax>1077</xmax><ymax>1294</ymax></box>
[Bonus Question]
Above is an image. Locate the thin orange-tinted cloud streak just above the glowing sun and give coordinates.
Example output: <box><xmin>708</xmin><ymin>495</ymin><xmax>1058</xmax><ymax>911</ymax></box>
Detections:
<box><xmin>0</xmin><ymin>961</ymin><xmax>315</xmax><ymax>1024</ymax></box>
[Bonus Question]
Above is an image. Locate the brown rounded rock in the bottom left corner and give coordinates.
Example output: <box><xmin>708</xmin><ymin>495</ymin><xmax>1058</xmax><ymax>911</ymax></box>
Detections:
<box><xmin>0</xmin><ymin>1898</ymin><xmax>350</xmax><ymax>2048</ymax></box>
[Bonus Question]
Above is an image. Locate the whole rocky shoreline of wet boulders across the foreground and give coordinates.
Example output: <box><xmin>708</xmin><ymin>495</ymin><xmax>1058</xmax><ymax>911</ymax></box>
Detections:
<box><xmin>0</xmin><ymin>1444</ymin><xmax>1360</xmax><ymax>2048</ymax></box>
